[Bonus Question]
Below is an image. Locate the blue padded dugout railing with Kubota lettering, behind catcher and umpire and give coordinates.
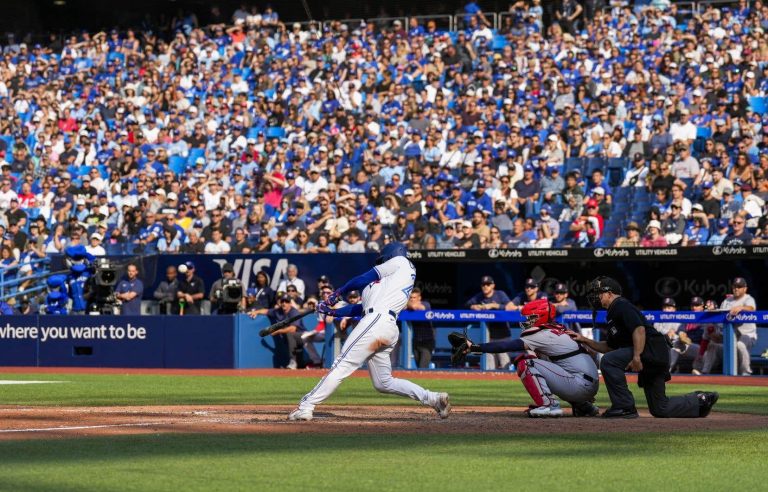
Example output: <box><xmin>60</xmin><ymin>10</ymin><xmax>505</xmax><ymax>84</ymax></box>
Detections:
<box><xmin>398</xmin><ymin>310</ymin><xmax>768</xmax><ymax>376</ymax></box>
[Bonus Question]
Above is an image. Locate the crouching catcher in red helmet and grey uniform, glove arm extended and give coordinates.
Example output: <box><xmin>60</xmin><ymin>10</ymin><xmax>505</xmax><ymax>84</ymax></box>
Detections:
<box><xmin>448</xmin><ymin>299</ymin><xmax>599</xmax><ymax>417</ymax></box>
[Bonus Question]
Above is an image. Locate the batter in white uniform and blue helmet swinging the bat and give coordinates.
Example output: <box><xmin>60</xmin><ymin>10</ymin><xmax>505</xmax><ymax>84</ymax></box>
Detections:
<box><xmin>288</xmin><ymin>242</ymin><xmax>451</xmax><ymax>420</ymax></box>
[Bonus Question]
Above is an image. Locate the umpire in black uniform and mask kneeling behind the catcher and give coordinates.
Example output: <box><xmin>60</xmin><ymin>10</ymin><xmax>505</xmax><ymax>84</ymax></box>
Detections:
<box><xmin>589</xmin><ymin>277</ymin><xmax>718</xmax><ymax>418</ymax></box>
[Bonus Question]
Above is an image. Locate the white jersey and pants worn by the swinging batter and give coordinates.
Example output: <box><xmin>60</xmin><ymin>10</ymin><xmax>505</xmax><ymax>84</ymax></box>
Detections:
<box><xmin>299</xmin><ymin>256</ymin><xmax>439</xmax><ymax>411</ymax></box>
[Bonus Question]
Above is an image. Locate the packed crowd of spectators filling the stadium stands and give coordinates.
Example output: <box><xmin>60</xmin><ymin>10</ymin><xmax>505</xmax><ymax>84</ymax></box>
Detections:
<box><xmin>0</xmin><ymin>0</ymin><xmax>768</xmax><ymax>276</ymax></box>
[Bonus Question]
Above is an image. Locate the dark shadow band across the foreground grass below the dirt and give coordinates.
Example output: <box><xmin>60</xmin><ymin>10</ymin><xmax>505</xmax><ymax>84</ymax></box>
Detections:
<box><xmin>0</xmin><ymin>430</ymin><xmax>768</xmax><ymax>466</ymax></box>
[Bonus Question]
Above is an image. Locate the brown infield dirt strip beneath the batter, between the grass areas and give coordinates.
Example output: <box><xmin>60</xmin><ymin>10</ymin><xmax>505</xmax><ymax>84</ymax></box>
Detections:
<box><xmin>0</xmin><ymin>405</ymin><xmax>768</xmax><ymax>440</ymax></box>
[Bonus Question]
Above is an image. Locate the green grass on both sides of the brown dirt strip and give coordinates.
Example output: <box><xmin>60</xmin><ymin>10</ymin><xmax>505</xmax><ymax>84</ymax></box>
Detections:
<box><xmin>0</xmin><ymin>374</ymin><xmax>768</xmax><ymax>491</ymax></box>
